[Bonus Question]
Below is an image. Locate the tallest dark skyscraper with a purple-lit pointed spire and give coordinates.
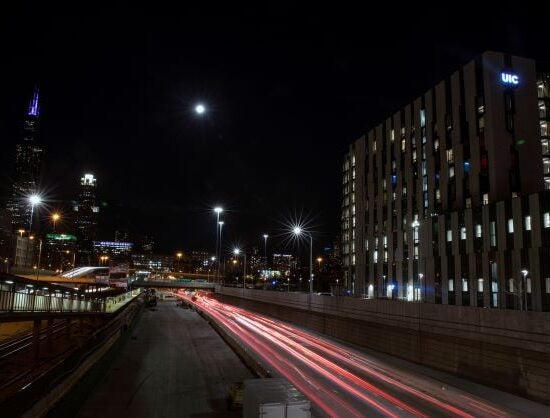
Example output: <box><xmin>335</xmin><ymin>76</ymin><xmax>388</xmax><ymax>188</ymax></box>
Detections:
<box><xmin>7</xmin><ymin>88</ymin><xmax>44</xmax><ymax>229</ymax></box>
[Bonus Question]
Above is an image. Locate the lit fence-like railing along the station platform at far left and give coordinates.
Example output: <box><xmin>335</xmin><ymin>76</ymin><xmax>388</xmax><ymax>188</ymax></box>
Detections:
<box><xmin>0</xmin><ymin>282</ymin><xmax>141</xmax><ymax>313</ymax></box>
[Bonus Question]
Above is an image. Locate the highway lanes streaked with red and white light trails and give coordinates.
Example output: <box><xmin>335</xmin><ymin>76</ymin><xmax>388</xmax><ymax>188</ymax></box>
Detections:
<box><xmin>180</xmin><ymin>291</ymin><xmax>545</xmax><ymax>417</ymax></box>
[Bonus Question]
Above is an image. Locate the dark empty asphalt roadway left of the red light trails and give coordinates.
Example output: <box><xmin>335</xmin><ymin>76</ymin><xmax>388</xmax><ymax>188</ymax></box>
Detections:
<box><xmin>72</xmin><ymin>299</ymin><xmax>254</xmax><ymax>418</ymax></box>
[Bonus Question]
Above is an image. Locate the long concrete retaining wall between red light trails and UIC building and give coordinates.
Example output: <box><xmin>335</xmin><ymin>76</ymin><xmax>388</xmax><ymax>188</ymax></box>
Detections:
<box><xmin>216</xmin><ymin>287</ymin><xmax>550</xmax><ymax>404</ymax></box>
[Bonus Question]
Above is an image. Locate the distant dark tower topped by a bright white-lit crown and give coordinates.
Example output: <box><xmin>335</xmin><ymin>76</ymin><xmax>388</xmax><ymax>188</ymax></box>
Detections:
<box><xmin>74</xmin><ymin>174</ymin><xmax>99</xmax><ymax>263</ymax></box>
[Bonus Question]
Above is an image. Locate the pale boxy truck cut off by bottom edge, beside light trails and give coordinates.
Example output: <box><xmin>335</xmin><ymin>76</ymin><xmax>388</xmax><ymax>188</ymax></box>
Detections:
<box><xmin>243</xmin><ymin>378</ymin><xmax>311</xmax><ymax>418</ymax></box>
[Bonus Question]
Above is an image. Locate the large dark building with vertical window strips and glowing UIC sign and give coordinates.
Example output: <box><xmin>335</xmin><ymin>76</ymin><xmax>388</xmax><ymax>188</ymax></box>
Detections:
<box><xmin>341</xmin><ymin>52</ymin><xmax>550</xmax><ymax>310</ymax></box>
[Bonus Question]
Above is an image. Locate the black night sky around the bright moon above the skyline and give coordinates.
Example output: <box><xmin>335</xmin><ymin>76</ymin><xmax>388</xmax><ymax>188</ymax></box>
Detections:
<box><xmin>0</xmin><ymin>6</ymin><xmax>550</xmax><ymax>252</ymax></box>
